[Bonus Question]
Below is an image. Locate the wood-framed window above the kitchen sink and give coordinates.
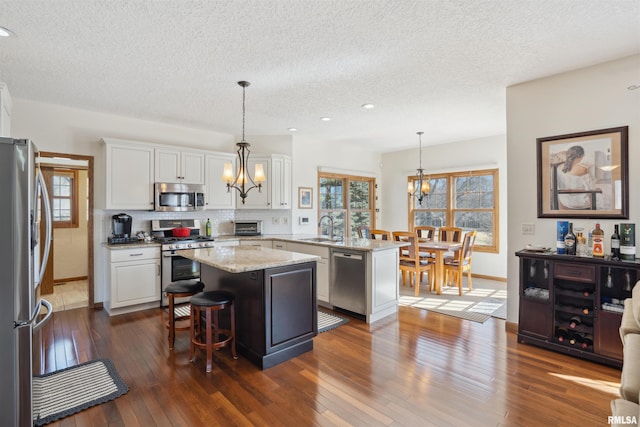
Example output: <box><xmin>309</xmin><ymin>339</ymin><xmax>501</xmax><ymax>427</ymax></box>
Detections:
<box><xmin>318</xmin><ymin>173</ymin><xmax>376</xmax><ymax>241</ymax></box>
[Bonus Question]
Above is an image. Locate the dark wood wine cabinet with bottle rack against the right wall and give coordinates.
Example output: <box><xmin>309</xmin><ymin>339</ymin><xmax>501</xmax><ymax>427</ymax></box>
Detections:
<box><xmin>516</xmin><ymin>250</ymin><xmax>640</xmax><ymax>368</ymax></box>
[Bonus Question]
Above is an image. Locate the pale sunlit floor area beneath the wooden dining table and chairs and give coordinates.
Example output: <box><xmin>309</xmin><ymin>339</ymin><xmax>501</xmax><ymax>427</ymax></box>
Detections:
<box><xmin>399</xmin><ymin>279</ymin><xmax>507</xmax><ymax>323</ymax></box>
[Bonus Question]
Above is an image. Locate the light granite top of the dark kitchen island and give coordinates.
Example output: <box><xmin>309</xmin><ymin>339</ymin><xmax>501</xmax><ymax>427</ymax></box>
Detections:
<box><xmin>180</xmin><ymin>245</ymin><xmax>321</xmax><ymax>273</ymax></box>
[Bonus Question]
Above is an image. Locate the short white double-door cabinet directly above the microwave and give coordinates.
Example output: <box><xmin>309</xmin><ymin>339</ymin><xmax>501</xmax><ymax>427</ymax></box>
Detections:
<box><xmin>155</xmin><ymin>148</ymin><xmax>205</xmax><ymax>184</ymax></box>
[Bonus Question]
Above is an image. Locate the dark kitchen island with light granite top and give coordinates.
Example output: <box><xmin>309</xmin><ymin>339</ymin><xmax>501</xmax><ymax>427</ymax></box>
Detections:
<box><xmin>180</xmin><ymin>246</ymin><xmax>320</xmax><ymax>369</ymax></box>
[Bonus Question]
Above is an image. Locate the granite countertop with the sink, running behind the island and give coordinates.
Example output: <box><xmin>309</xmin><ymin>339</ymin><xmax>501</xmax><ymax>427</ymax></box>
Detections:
<box><xmin>214</xmin><ymin>234</ymin><xmax>408</xmax><ymax>252</ymax></box>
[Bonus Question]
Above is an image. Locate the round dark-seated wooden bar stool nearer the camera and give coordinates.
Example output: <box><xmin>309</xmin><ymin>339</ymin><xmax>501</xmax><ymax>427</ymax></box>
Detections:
<box><xmin>189</xmin><ymin>291</ymin><xmax>238</xmax><ymax>372</ymax></box>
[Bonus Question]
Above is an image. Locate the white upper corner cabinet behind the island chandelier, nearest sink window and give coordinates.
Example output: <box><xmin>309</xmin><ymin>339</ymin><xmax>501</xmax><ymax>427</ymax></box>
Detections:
<box><xmin>236</xmin><ymin>154</ymin><xmax>291</xmax><ymax>209</ymax></box>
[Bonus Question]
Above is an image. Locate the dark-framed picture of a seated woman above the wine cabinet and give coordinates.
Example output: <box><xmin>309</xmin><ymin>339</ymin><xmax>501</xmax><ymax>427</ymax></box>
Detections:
<box><xmin>536</xmin><ymin>126</ymin><xmax>629</xmax><ymax>219</ymax></box>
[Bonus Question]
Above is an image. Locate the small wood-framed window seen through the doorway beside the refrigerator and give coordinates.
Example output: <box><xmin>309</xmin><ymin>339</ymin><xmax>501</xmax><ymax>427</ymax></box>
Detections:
<box><xmin>51</xmin><ymin>169</ymin><xmax>78</xmax><ymax>228</ymax></box>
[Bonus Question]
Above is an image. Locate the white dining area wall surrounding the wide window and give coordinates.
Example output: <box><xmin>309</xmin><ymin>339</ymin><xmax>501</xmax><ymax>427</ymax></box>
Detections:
<box><xmin>379</xmin><ymin>135</ymin><xmax>507</xmax><ymax>278</ymax></box>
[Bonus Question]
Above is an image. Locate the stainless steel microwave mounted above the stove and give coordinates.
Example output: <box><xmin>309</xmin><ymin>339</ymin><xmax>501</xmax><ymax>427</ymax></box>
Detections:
<box><xmin>154</xmin><ymin>182</ymin><xmax>207</xmax><ymax>212</ymax></box>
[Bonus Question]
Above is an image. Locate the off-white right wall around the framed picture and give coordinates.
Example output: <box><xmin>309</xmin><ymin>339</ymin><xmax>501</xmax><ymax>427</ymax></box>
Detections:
<box><xmin>507</xmin><ymin>55</ymin><xmax>640</xmax><ymax>322</ymax></box>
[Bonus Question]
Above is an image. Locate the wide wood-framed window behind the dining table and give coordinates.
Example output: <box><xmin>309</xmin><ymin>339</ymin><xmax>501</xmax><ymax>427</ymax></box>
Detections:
<box><xmin>408</xmin><ymin>169</ymin><xmax>498</xmax><ymax>252</ymax></box>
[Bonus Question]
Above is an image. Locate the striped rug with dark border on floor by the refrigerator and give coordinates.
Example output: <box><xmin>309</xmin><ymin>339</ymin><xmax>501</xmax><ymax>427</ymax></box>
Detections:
<box><xmin>33</xmin><ymin>359</ymin><xmax>129</xmax><ymax>426</ymax></box>
